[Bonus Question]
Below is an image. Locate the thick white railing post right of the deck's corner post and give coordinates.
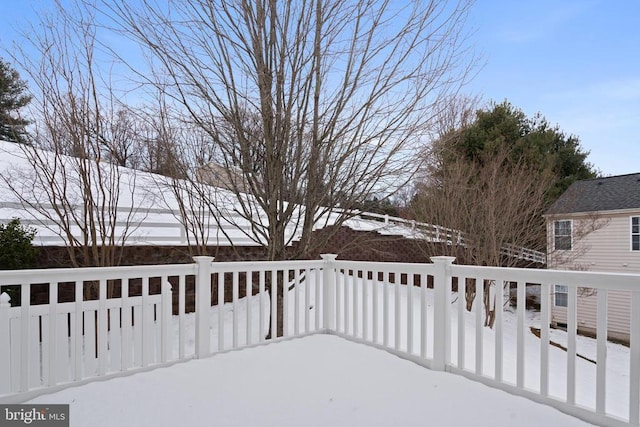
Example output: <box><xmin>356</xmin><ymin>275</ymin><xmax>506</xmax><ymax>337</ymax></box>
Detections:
<box><xmin>431</xmin><ymin>256</ymin><xmax>456</xmax><ymax>371</ymax></box>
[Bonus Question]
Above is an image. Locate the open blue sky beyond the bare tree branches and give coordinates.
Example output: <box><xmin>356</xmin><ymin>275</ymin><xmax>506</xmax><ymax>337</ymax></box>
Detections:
<box><xmin>0</xmin><ymin>0</ymin><xmax>640</xmax><ymax>175</ymax></box>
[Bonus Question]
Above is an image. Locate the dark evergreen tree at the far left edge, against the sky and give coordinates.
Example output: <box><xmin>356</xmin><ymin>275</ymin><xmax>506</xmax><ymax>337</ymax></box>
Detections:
<box><xmin>0</xmin><ymin>59</ymin><xmax>31</xmax><ymax>143</ymax></box>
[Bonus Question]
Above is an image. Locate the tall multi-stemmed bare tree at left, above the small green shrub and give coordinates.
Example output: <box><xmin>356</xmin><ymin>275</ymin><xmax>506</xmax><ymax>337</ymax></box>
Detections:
<box><xmin>2</xmin><ymin>2</ymin><xmax>149</xmax><ymax>267</ymax></box>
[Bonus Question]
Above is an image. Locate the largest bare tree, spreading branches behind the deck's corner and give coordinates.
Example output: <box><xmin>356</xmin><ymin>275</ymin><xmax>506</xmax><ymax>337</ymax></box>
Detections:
<box><xmin>104</xmin><ymin>0</ymin><xmax>475</xmax><ymax>340</ymax></box>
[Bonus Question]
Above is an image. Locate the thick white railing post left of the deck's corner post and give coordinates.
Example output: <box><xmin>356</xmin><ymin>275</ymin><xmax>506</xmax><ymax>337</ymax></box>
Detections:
<box><xmin>193</xmin><ymin>256</ymin><xmax>214</xmax><ymax>359</ymax></box>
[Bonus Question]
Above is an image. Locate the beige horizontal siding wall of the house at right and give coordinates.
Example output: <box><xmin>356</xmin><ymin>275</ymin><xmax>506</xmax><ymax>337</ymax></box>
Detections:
<box><xmin>547</xmin><ymin>210</ymin><xmax>640</xmax><ymax>340</ymax></box>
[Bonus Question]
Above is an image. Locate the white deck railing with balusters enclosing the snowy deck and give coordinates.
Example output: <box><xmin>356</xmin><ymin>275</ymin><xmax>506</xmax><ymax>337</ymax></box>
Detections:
<box><xmin>0</xmin><ymin>255</ymin><xmax>640</xmax><ymax>425</ymax></box>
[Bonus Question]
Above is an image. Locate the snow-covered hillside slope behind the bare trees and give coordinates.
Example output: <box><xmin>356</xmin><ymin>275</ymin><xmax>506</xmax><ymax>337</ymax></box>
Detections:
<box><xmin>0</xmin><ymin>141</ymin><xmax>425</xmax><ymax>246</ymax></box>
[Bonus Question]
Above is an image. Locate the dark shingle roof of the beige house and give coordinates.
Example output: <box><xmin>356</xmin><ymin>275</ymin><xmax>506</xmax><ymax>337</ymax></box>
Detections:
<box><xmin>547</xmin><ymin>173</ymin><xmax>640</xmax><ymax>215</ymax></box>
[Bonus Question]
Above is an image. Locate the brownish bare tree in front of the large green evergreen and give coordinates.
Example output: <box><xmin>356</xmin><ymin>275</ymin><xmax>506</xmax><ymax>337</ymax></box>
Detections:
<box><xmin>412</xmin><ymin>142</ymin><xmax>552</xmax><ymax>326</ymax></box>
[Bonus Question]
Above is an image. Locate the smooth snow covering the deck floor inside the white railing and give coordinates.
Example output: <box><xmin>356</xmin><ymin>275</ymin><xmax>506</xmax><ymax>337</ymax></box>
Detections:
<box><xmin>31</xmin><ymin>335</ymin><xmax>588</xmax><ymax>427</ymax></box>
